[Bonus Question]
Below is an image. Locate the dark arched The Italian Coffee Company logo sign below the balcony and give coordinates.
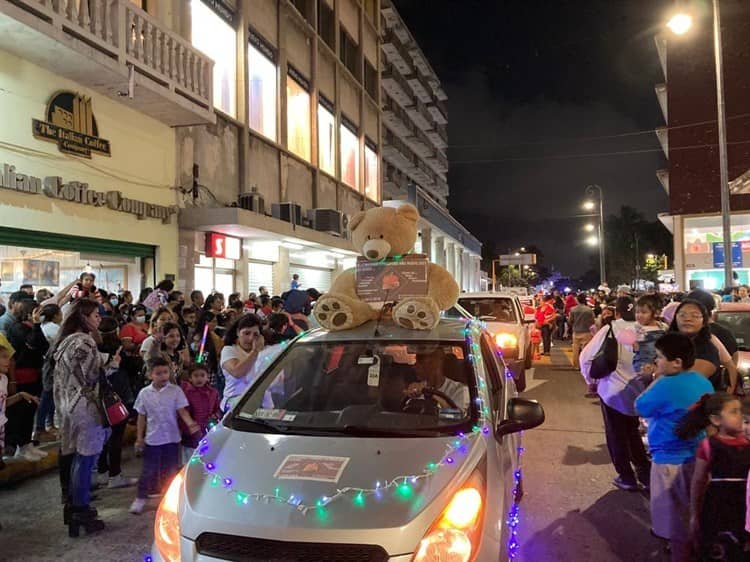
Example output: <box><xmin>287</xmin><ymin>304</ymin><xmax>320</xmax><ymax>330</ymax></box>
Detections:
<box><xmin>31</xmin><ymin>92</ymin><xmax>112</xmax><ymax>158</ymax></box>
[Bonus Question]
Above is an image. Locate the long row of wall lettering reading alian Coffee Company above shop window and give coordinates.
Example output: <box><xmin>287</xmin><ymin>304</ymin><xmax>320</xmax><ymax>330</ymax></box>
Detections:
<box><xmin>0</xmin><ymin>164</ymin><xmax>177</xmax><ymax>224</ymax></box>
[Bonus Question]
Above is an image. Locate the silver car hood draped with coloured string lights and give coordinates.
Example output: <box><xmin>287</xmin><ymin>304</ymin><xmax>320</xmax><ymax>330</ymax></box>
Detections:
<box><xmin>181</xmin><ymin>425</ymin><xmax>486</xmax><ymax>544</ymax></box>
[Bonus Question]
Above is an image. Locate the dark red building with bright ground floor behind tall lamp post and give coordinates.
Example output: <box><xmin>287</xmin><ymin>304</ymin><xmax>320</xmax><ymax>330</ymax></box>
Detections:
<box><xmin>656</xmin><ymin>4</ymin><xmax>750</xmax><ymax>289</ymax></box>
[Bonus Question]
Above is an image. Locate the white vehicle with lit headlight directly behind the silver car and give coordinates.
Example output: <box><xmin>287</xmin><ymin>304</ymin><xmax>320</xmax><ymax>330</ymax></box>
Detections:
<box><xmin>445</xmin><ymin>292</ymin><xmax>534</xmax><ymax>390</ymax></box>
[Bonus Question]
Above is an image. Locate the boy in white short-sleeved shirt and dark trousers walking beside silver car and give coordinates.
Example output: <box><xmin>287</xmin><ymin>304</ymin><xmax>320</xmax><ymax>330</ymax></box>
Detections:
<box><xmin>130</xmin><ymin>357</ymin><xmax>200</xmax><ymax>513</ymax></box>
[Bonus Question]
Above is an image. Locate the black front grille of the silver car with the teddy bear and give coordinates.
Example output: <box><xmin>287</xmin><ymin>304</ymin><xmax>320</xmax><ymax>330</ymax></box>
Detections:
<box><xmin>196</xmin><ymin>533</ymin><xmax>388</xmax><ymax>562</ymax></box>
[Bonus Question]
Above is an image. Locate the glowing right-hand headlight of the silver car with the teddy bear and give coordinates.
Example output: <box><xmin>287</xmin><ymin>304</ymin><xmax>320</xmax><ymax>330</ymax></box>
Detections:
<box><xmin>413</xmin><ymin>470</ymin><xmax>484</xmax><ymax>562</ymax></box>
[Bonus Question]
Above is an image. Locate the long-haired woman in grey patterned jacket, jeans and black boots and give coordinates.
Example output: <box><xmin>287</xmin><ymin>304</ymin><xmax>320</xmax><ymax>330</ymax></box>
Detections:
<box><xmin>53</xmin><ymin>299</ymin><xmax>120</xmax><ymax>537</ymax></box>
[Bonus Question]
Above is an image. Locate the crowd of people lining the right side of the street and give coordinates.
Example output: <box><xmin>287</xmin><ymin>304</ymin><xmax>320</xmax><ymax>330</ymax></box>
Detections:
<box><xmin>535</xmin><ymin>287</ymin><xmax>750</xmax><ymax>562</ymax></box>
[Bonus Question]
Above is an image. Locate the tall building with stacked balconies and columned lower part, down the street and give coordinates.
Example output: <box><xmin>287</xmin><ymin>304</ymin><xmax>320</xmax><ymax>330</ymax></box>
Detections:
<box><xmin>381</xmin><ymin>0</ymin><xmax>482</xmax><ymax>291</ymax></box>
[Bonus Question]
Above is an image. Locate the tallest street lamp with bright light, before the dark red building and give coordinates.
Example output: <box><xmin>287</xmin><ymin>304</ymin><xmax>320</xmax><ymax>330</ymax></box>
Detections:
<box><xmin>667</xmin><ymin>0</ymin><xmax>733</xmax><ymax>287</ymax></box>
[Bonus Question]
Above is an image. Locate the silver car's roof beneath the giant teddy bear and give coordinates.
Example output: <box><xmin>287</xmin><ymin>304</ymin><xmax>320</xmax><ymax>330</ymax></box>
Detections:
<box><xmin>298</xmin><ymin>318</ymin><xmax>467</xmax><ymax>343</ymax></box>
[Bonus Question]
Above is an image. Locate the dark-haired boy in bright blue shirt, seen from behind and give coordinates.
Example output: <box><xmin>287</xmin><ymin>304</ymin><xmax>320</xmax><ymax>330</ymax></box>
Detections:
<box><xmin>635</xmin><ymin>332</ymin><xmax>713</xmax><ymax>562</ymax></box>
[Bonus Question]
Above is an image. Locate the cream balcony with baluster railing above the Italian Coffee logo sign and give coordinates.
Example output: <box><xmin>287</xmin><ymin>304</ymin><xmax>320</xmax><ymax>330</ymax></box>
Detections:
<box><xmin>0</xmin><ymin>0</ymin><xmax>215</xmax><ymax>125</ymax></box>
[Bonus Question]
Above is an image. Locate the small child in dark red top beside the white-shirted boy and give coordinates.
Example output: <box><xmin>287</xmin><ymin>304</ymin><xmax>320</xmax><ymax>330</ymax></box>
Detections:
<box><xmin>180</xmin><ymin>364</ymin><xmax>221</xmax><ymax>464</ymax></box>
